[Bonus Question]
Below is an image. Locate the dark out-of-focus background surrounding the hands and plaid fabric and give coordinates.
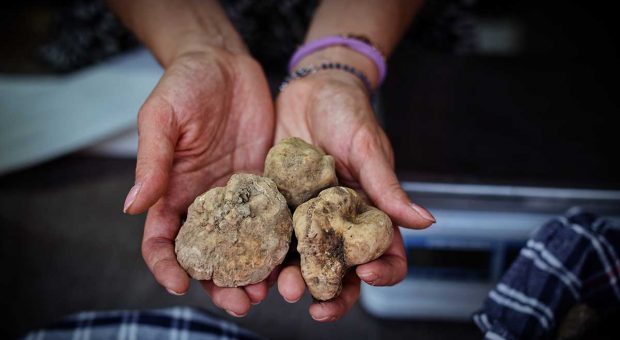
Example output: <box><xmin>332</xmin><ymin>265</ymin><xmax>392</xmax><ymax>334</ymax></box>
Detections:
<box><xmin>0</xmin><ymin>0</ymin><xmax>620</xmax><ymax>339</ymax></box>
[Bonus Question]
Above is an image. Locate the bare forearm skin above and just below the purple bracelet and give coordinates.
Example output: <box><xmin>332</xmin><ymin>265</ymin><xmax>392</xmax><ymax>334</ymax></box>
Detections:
<box><xmin>299</xmin><ymin>0</ymin><xmax>423</xmax><ymax>85</ymax></box>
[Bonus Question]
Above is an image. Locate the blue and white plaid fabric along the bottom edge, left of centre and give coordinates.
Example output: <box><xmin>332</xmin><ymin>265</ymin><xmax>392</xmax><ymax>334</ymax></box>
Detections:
<box><xmin>22</xmin><ymin>307</ymin><xmax>262</xmax><ymax>340</ymax></box>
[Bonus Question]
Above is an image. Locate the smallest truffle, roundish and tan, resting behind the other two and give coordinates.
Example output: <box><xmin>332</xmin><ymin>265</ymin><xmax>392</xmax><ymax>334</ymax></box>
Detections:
<box><xmin>265</xmin><ymin>137</ymin><xmax>338</xmax><ymax>208</ymax></box>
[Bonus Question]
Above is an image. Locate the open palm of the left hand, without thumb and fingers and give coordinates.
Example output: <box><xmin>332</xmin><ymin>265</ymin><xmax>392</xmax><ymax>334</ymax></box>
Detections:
<box><xmin>149</xmin><ymin>51</ymin><xmax>273</xmax><ymax>213</ymax></box>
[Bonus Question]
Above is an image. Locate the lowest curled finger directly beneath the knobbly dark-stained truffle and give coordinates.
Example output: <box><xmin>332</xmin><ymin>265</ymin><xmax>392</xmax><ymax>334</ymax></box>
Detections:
<box><xmin>310</xmin><ymin>272</ymin><xmax>360</xmax><ymax>322</ymax></box>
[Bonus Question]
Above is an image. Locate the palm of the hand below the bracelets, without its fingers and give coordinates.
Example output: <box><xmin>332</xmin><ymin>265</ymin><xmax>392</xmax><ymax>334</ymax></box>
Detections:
<box><xmin>275</xmin><ymin>74</ymin><xmax>393</xmax><ymax>194</ymax></box>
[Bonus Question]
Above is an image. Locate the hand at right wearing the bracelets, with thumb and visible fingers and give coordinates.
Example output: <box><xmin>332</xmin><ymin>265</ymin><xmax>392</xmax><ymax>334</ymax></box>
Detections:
<box><xmin>275</xmin><ymin>70</ymin><xmax>435</xmax><ymax>321</ymax></box>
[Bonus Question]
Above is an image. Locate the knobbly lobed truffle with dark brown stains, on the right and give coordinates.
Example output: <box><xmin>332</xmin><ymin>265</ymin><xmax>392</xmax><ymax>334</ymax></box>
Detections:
<box><xmin>293</xmin><ymin>187</ymin><xmax>393</xmax><ymax>301</ymax></box>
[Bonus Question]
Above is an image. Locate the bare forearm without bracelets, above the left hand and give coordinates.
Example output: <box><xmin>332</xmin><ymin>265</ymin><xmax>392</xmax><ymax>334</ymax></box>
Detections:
<box><xmin>107</xmin><ymin>0</ymin><xmax>247</xmax><ymax>67</ymax></box>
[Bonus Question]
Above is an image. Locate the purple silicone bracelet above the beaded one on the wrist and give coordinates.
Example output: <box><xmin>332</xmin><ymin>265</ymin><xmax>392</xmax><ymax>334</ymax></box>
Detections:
<box><xmin>288</xmin><ymin>35</ymin><xmax>387</xmax><ymax>86</ymax></box>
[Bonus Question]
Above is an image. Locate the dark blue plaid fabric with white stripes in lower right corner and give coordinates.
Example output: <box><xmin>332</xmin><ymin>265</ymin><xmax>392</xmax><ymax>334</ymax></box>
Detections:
<box><xmin>473</xmin><ymin>209</ymin><xmax>620</xmax><ymax>339</ymax></box>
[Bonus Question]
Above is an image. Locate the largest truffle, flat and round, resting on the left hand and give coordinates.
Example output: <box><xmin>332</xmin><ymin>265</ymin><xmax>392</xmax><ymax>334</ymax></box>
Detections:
<box><xmin>175</xmin><ymin>174</ymin><xmax>292</xmax><ymax>287</ymax></box>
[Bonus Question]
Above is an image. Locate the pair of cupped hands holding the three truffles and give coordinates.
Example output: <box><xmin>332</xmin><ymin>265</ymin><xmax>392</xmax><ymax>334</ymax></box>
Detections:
<box><xmin>124</xmin><ymin>48</ymin><xmax>434</xmax><ymax>321</ymax></box>
